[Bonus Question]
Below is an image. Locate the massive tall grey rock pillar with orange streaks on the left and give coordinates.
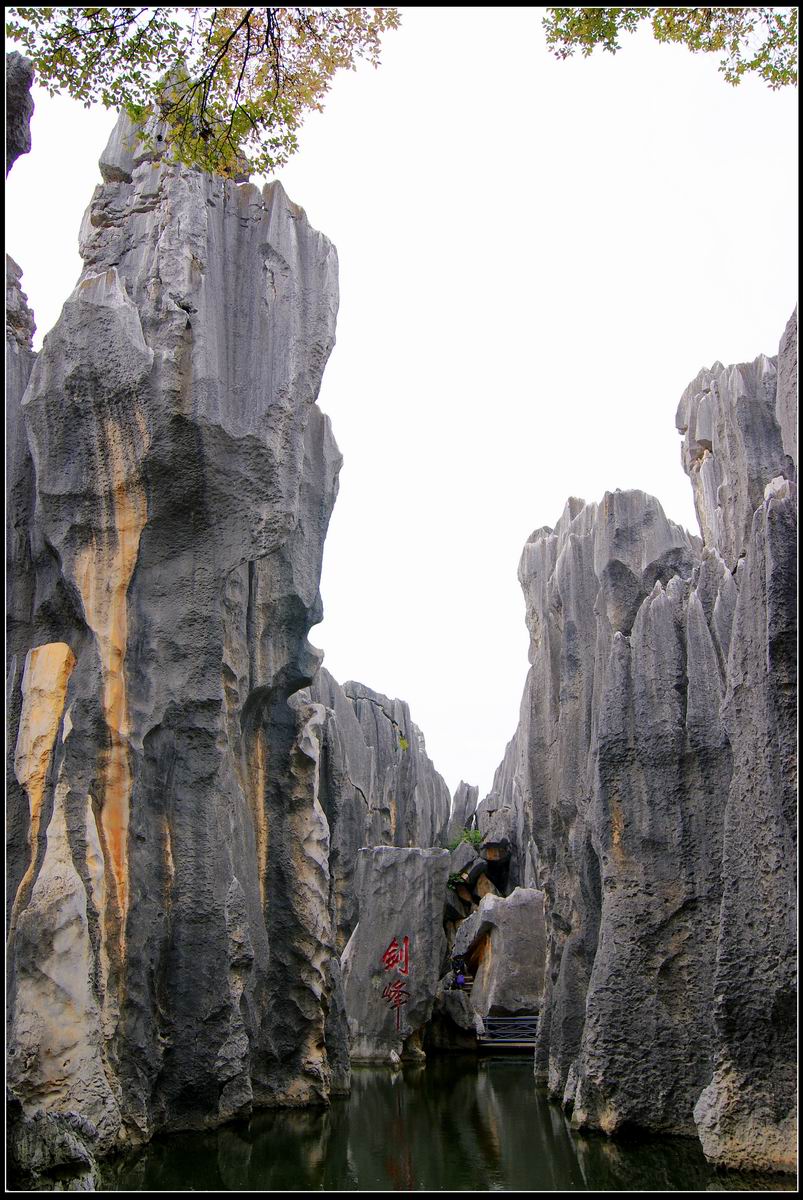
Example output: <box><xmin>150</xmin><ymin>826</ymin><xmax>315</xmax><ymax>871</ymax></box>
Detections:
<box><xmin>7</xmin><ymin>103</ymin><xmax>342</xmax><ymax>1171</ymax></box>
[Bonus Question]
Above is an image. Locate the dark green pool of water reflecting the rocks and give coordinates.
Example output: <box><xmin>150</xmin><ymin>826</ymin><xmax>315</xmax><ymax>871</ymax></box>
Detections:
<box><xmin>103</xmin><ymin>1056</ymin><xmax>795</xmax><ymax>1192</ymax></box>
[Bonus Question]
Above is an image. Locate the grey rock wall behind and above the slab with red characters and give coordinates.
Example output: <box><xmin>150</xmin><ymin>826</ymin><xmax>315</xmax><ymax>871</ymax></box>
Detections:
<box><xmin>308</xmin><ymin>667</ymin><xmax>450</xmax><ymax>950</ymax></box>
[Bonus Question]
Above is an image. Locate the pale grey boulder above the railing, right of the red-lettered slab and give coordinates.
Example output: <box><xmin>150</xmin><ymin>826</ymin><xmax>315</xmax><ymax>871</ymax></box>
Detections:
<box><xmin>451</xmin><ymin>888</ymin><xmax>546</xmax><ymax>1016</ymax></box>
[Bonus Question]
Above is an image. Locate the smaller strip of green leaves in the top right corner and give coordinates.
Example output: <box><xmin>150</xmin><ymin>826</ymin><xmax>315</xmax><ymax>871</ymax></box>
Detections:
<box><xmin>544</xmin><ymin>8</ymin><xmax>797</xmax><ymax>89</ymax></box>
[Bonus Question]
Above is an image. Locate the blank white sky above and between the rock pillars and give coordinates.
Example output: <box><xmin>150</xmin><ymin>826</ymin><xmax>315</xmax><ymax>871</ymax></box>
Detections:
<box><xmin>7</xmin><ymin>7</ymin><xmax>797</xmax><ymax>796</ymax></box>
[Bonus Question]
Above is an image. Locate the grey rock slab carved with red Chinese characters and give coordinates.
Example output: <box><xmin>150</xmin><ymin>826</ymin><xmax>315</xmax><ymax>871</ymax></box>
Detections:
<box><xmin>341</xmin><ymin>846</ymin><xmax>449</xmax><ymax>1062</ymax></box>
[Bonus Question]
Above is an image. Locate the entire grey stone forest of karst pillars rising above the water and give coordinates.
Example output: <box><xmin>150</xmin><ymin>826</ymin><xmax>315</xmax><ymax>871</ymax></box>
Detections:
<box><xmin>6</xmin><ymin>46</ymin><xmax>797</xmax><ymax>1189</ymax></box>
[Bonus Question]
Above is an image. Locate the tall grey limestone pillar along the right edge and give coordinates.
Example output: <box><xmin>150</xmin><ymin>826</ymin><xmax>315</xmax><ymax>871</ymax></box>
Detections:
<box><xmin>678</xmin><ymin>313</ymin><xmax>797</xmax><ymax>1171</ymax></box>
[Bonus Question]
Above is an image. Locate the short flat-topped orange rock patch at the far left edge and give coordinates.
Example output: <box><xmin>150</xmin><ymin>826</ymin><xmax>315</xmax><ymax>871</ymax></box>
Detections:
<box><xmin>12</xmin><ymin>642</ymin><xmax>76</xmax><ymax>922</ymax></box>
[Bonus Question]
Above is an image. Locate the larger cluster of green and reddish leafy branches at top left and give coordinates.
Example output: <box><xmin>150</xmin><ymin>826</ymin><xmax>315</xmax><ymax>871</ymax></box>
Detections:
<box><xmin>6</xmin><ymin>7</ymin><xmax>400</xmax><ymax>176</ymax></box>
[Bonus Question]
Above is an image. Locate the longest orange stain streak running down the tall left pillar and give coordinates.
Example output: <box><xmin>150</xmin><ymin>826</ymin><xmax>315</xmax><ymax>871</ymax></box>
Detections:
<box><xmin>74</xmin><ymin>421</ymin><xmax>148</xmax><ymax>946</ymax></box>
